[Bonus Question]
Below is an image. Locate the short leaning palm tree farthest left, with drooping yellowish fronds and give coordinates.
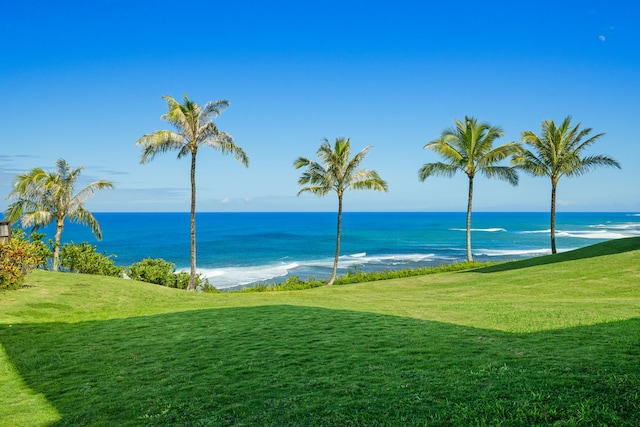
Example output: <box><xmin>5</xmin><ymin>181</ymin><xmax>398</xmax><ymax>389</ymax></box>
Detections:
<box><xmin>5</xmin><ymin>159</ymin><xmax>113</xmax><ymax>271</ymax></box>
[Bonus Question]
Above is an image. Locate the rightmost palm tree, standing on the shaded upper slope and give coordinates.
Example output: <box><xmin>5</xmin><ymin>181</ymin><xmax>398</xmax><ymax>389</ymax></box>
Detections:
<box><xmin>512</xmin><ymin>116</ymin><xmax>620</xmax><ymax>254</ymax></box>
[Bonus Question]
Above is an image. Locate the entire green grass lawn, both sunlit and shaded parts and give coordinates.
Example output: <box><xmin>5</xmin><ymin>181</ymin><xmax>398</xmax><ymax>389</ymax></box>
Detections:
<box><xmin>0</xmin><ymin>238</ymin><xmax>640</xmax><ymax>426</ymax></box>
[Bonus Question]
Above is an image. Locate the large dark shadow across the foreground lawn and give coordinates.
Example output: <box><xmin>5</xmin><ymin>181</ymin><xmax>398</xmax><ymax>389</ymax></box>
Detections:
<box><xmin>0</xmin><ymin>306</ymin><xmax>640</xmax><ymax>426</ymax></box>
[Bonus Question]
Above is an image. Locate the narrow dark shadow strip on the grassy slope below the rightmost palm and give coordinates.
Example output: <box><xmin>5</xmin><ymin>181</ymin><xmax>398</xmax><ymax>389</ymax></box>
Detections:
<box><xmin>469</xmin><ymin>237</ymin><xmax>640</xmax><ymax>273</ymax></box>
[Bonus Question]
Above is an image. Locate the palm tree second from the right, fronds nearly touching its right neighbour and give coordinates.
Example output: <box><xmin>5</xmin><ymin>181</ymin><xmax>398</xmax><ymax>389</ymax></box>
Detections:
<box><xmin>419</xmin><ymin>116</ymin><xmax>519</xmax><ymax>261</ymax></box>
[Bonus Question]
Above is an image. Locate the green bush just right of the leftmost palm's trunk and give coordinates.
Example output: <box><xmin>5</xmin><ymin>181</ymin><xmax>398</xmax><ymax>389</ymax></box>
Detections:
<box><xmin>60</xmin><ymin>242</ymin><xmax>124</xmax><ymax>277</ymax></box>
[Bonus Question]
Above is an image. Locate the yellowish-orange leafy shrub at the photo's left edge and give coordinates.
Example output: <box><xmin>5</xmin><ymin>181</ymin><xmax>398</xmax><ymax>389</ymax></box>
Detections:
<box><xmin>0</xmin><ymin>229</ymin><xmax>45</xmax><ymax>289</ymax></box>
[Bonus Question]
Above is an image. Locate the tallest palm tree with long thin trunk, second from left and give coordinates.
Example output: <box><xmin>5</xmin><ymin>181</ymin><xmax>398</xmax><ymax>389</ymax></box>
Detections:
<box><xmin>136</xmin><ymin>94</ymin><xmax>249</xmax><ymax>291</ymax></box>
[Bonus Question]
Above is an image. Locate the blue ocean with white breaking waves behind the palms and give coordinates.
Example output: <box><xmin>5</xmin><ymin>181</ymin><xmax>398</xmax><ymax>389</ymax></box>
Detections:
<box><xmin>33</xmin><ymin>212</ymin><xmax>640</xmax><ymax>289</ymax></box>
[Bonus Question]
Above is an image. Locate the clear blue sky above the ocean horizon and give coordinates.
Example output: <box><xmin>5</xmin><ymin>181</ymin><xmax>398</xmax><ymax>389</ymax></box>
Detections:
<box><xmin>0</xmin><ymin>0</ymin><xmax>640</xmax><ymax>212</ymax></box>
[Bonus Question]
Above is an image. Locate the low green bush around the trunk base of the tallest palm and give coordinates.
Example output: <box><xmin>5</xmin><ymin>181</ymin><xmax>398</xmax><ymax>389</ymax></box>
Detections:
<box><xmin>127</xmin><ymin>258</ymin><xmax>215</xmax><ymax>292</ymax></box>
